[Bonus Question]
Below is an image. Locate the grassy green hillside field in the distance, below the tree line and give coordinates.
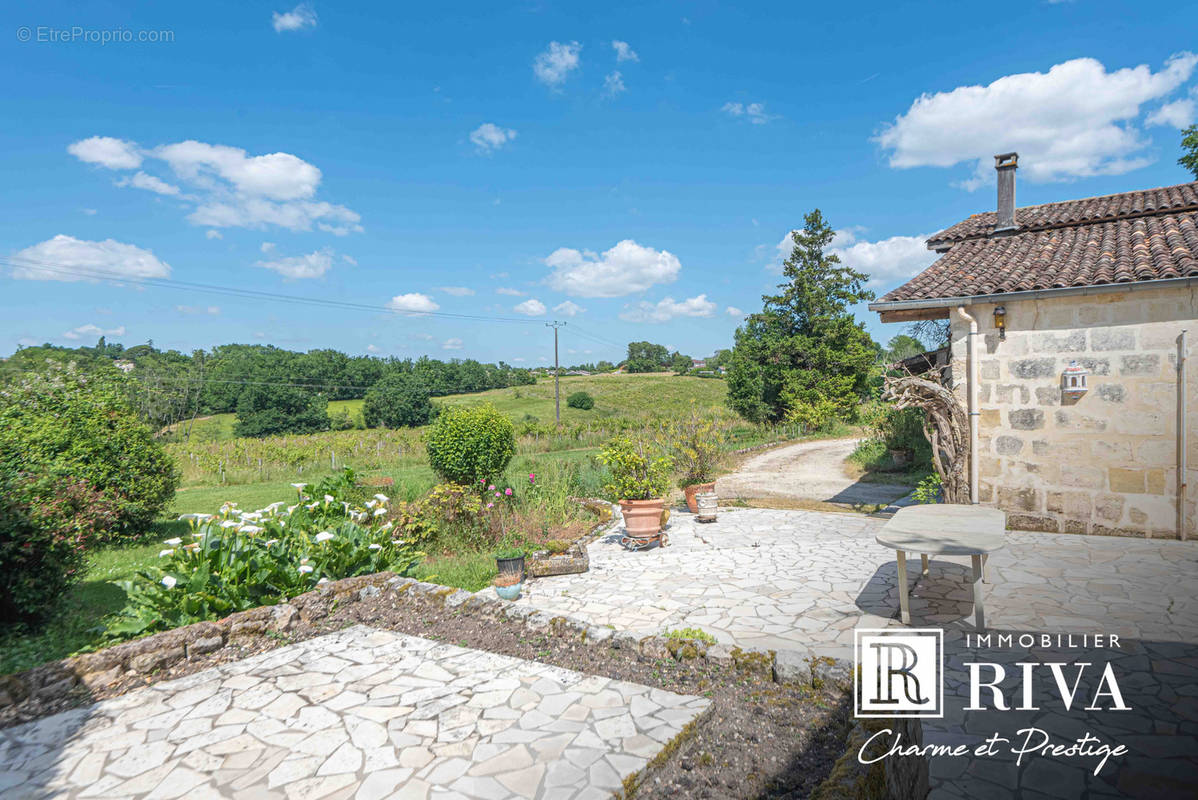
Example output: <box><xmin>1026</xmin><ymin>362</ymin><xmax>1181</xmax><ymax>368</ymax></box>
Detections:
<box><xmin>168</xmin><ymin>372</ymin><xmax>727</xmax><ymax>442</ymax></box>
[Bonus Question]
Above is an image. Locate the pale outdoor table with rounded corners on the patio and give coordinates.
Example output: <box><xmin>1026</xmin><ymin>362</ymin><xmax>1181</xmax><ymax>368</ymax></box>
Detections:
<box><xmin>877</xmin><ymin>504</ymin><xmax>1006</xmax><ymax>630</ymax></box>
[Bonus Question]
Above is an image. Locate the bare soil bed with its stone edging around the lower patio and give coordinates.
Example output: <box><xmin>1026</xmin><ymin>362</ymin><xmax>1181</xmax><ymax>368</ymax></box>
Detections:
<box><xmin>7</xmin><ymin>574</ymin><xmax>849</xmax><ymax>798</ymax></box>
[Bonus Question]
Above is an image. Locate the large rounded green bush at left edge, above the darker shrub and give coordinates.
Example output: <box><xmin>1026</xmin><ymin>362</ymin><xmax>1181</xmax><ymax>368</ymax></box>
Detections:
<box><xmin>0</xmin><ymin>365</ymin><xmax>179</xmax><ymax>539</ymax></box>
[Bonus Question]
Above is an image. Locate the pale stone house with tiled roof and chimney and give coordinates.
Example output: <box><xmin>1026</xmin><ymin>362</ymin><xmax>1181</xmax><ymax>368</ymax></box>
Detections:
<box><xmin>870</xmin><ymin>153</ymin><xmax>1198</xmax><ymax>538</ymax></box>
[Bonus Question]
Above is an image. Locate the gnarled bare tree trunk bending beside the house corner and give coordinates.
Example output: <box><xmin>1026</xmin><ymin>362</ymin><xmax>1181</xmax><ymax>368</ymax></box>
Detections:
<box><xmin>882</xmin><ymin>375</ymin><xmax>969</xmax><ymax>503</ymax></box>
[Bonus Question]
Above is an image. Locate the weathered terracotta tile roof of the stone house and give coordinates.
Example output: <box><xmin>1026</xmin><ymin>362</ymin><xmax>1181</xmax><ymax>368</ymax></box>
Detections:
<box><xmin>879</xmin><ymin>182</ymin><xmax>1198</xmax><ymax>303</ymax></box>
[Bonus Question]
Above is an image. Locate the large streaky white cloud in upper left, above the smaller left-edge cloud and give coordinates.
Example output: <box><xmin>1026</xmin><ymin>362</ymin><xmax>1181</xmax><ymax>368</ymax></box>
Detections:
<box><xmin>67</xmin><ymin>137</ymin><xmax>363</xmax><ymax>236</ymax></box>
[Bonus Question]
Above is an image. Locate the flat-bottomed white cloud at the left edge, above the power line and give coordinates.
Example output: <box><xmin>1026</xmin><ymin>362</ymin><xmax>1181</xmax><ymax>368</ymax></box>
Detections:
<box><xmin>12</xmin><ymin>234</ymin><xmax>170</xmax><ymax>283</ymax></box>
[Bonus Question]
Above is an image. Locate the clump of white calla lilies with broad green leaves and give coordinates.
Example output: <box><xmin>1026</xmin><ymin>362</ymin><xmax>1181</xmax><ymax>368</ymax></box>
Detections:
<box><xmin>108</xmin><ymin>475</ymin><xmax>422</xmax><ymax>638</ymax></box>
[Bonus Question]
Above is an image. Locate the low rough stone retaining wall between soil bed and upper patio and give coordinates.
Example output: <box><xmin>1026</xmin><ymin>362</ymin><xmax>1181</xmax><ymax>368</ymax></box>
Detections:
<box><xmin>0</xmin><ymin>572</ymin><xmax>846</xmax><ymax>726</ymax></box>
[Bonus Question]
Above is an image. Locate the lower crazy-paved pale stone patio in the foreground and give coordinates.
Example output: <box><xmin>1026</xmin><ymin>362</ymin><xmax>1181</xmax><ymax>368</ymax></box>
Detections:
<box><xmin>0</xmin><ymin>625</ymin><xmax>710</xmax><ymax>800</ymax></box>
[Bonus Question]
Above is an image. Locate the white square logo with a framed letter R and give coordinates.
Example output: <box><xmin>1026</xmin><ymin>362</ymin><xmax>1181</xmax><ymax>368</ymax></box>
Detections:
<box><xmin>853</xmin><ymin>628</ymin><xmax>944</xmax><ymax>717</ymax></box>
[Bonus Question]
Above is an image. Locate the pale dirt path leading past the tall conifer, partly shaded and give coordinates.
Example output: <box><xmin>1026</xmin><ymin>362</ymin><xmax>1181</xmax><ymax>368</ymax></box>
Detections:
<box><xmin>715</xmin><ymin>438</ymin><xmax>910</xmax><ymax>505</ymax></box>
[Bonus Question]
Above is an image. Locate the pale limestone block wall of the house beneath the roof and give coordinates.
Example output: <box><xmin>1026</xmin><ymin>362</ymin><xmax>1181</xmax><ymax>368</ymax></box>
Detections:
<box><xmin>952</xmin><ymin>287</ymin><xmax>1198</xmax><ymax>539</ymax></box>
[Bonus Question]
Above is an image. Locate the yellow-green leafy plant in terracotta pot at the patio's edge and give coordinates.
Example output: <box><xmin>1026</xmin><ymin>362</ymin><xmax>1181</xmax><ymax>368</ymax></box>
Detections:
<box><xmin>599</xmin><ymin>437</ymin><xmax>673</xmax><ymax>538</ymax></box>
